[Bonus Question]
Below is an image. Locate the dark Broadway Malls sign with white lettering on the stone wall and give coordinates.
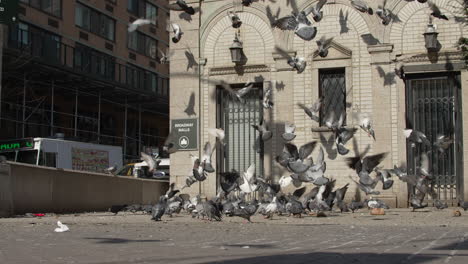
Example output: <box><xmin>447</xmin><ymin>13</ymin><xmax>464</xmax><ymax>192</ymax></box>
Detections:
<box><xmin>171</xmin><ymin>118</ymin><xmax>198</xmax><ymax>150</ymax></box>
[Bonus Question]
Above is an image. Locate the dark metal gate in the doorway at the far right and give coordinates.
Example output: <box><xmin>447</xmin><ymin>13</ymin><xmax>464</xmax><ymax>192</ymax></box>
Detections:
<box><xmin>406</xmin><ymin>73</ymin><xmax>463</xmax><ymax>205</ymax></box>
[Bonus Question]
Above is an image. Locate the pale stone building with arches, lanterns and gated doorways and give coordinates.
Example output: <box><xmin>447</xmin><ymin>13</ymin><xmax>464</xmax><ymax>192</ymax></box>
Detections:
<box><xmin>170</xmin><ymin>0</ymin><xmax>468</xmax><ymax>207</ymax></box>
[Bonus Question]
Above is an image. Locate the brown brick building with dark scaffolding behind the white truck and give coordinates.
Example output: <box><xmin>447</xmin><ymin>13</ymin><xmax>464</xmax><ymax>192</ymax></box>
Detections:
<box><xmin>0</xmin><ymin>0</ymin><xmax>169</xmax><ymax>160</ymax></box>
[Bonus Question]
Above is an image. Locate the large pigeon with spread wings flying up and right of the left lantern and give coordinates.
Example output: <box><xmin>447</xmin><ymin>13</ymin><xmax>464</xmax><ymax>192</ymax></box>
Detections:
<box><xmin>272</xmin><ymin>7</ymin><xmax>317</xmax><ymax>41</ymax></box>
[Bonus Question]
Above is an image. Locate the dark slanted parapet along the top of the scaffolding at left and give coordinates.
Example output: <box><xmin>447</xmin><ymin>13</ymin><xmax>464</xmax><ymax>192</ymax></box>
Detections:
<box><xmin>8</xmin><ymin>27</ymin><xmax>169</xmax><ymax>100</ymax></box>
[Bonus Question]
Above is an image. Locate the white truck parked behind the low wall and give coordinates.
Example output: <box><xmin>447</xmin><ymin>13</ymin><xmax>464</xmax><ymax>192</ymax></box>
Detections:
<box><xmin>0</xmin><ymin>138</ymin><xmax>123</xmax><ymax>172</ymax></box>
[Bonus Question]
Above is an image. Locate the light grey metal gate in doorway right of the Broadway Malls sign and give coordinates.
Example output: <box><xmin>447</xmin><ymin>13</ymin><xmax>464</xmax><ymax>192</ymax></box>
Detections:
<box><xmin>216</xmin><ymin>83</ymin><xmax>263</xmax><ymax>184</ymax></box>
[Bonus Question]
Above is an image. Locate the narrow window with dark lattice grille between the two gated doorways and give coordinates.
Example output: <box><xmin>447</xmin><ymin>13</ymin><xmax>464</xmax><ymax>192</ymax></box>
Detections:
<box><xmin>319</xmin><ymin>68</ymin><xmax>346</xmax><ymax>126</ymax></box>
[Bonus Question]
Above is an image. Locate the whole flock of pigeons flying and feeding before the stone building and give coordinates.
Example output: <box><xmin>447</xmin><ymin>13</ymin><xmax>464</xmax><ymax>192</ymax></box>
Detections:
<box><xmin>117</xmin><ymin>0</ymin><xmax>464</xmax><ymax>221</ymax></box>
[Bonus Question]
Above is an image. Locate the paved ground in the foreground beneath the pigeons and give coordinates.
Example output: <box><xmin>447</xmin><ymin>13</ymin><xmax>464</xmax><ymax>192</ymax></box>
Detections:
<box><xmin>0</xmin><ymin>208</ymin><xmax>468</xmax><ymax>264</ymax></box>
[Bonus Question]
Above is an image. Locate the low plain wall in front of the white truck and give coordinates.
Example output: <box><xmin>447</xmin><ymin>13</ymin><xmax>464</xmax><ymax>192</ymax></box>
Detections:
<box><xmin>0</xmin><ymin>162</ymin><xmax>169</xmax><ymax>216</ymax></box>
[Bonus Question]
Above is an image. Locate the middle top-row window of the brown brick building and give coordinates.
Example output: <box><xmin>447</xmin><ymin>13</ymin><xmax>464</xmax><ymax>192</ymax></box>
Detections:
<box><xmin>75</xmin><ymin>3</ymin><xmax>115</xmax><ymax>41</ymax></box>
